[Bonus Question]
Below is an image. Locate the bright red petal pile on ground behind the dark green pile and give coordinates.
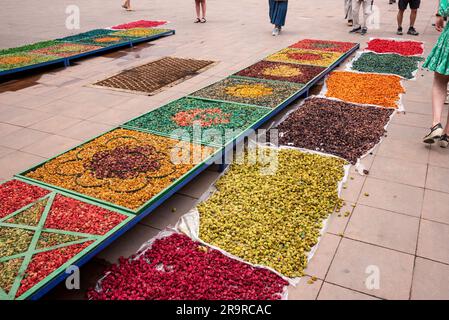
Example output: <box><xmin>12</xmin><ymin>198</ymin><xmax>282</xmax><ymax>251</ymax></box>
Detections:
<box><xmin>367</xmin><ymin>39</ymin><xmax>424</xmax><ymax>56</ymax></box>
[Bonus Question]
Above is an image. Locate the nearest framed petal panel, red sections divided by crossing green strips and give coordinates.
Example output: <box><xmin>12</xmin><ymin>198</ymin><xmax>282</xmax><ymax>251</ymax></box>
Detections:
<box><xmin>0</xmin><ymin>180</ymin><xmax>130</xmax><ymax>300</ymax></box>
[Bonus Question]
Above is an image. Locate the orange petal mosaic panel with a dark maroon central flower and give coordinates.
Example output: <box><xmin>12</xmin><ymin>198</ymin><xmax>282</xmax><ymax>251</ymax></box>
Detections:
<box><xmin>25</xmin><ymin>129</ymin><xmax>215</xmax><ymax>212</ymax></box>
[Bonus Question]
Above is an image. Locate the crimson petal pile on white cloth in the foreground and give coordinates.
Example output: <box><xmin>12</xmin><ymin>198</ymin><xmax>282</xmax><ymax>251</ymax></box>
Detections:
<box><xmin>88</xmin><ymin>234</ymin><xmax>288</xmax><ymax>300</ymax></box>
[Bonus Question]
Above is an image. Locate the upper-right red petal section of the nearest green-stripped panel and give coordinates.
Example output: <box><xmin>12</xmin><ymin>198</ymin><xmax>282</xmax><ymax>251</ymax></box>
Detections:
<box><xmin>45</xmin><ymin>194</ymin><xmax>126</xmax><ymax>235</ymax></box>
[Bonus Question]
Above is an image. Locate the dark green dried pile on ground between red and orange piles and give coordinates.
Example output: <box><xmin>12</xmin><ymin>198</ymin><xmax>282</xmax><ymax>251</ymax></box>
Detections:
<box><xmin>352</xmin><ymin>52</ymin><xmax>423</xmax><ymax>79</ymax></box>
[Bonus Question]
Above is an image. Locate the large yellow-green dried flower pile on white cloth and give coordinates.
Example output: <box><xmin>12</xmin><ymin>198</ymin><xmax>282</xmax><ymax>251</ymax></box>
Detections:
<box><xmin>198</xmin><ymin>148</ymin><xmax>347</xmax><ymax>277</ymax></box>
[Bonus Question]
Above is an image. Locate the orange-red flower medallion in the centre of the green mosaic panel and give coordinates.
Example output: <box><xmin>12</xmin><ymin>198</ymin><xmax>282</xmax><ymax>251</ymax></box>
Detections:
<box><xmin>173</xmin><ymin>108</ymin><xmax>231</xmax><ymax>128</ymax></box>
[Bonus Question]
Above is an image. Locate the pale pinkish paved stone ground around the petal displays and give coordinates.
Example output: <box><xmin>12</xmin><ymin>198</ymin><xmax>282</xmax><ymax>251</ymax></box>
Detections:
<box><xmin>0</xmin><ymin>0</ymin><xmax>449</xmax><ymax>299</ymax></box>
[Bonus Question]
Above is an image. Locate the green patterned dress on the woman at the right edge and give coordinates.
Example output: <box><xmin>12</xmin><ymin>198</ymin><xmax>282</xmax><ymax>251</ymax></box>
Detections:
<box><xmin>423</xmin><ymin>0</ymin><xmax>449</xmax><ymax>75</ymax></box>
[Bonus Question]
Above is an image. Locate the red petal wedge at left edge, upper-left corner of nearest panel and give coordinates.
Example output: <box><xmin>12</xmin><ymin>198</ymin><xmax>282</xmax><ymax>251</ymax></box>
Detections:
<box><xmin>0</xmin><ymin>180</ymin><xmax>50</xmax><ymax>218</ymax></box>
